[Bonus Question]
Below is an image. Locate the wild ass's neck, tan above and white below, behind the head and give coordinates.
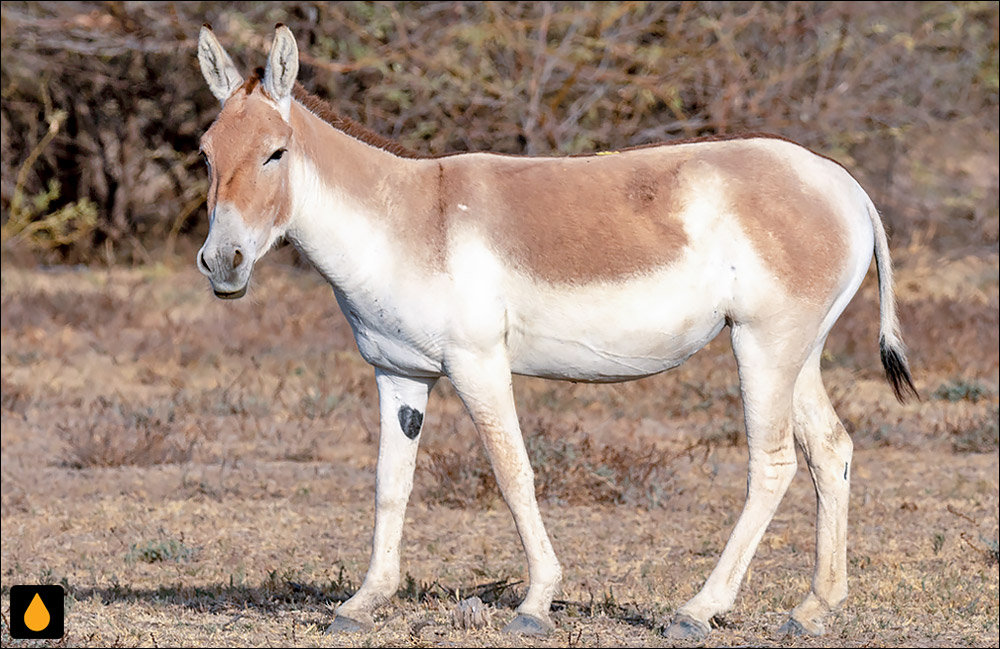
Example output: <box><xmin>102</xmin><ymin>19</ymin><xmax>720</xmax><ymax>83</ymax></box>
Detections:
<box><xmin>287</xmin><ymin>101</ymin><xmax>436</xmax><ymax>292</ymax></box>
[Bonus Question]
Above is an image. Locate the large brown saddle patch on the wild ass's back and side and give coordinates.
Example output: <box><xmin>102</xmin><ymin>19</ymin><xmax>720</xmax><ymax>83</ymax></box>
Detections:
<box><xmin>439</xmin><ymin>149</ymin><xmax>688</xmax><ymax>284</ymax></box>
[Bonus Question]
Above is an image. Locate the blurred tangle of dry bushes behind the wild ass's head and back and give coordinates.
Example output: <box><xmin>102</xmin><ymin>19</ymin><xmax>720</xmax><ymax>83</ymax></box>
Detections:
<box><xmin>0</xmin><ymin>2</ymin><xmax>1000</xmax><ymax>264</ymax></box>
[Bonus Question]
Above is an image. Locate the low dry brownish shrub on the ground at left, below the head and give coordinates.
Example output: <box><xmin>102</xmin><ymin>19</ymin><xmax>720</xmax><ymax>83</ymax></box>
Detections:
<box><xmin>59</xmin><ymin>397</ymin><xmax>198</xmax><ymax>469</ymax></box>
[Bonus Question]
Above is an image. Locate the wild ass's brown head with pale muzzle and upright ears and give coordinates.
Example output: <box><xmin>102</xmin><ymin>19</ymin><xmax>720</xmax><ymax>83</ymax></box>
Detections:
<box><xmin>198</xmin><ymin>25</ymin><xmax>299</xmax><ymax>299</ymax></box>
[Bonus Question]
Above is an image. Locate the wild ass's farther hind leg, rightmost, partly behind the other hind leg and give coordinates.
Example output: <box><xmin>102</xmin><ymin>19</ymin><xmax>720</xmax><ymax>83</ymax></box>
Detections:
<box><xmin>782</xmin><ymin>347</ymin><xmax>854</xmax><ymax>635</ymax></box>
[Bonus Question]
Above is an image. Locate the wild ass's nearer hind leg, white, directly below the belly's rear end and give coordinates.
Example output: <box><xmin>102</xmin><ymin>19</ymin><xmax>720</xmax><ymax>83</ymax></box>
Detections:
<box><xmin>665</xmin><ymin>325</ymin><xmax>806</xmax><ymax>640</ymax></box>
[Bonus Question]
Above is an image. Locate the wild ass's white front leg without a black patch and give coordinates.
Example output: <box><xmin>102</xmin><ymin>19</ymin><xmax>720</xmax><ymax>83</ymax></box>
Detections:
<box><xmin>449</xmin><ymin>348</ymin><xmax>562</xmax><ymax>635</ymax></box>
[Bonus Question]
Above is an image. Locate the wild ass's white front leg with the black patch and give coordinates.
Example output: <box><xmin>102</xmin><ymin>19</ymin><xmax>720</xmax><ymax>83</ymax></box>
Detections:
<box><xmin>327</xmin><ymin>370</ymin><xmax>436</xmax><ymax>632</ymax></box>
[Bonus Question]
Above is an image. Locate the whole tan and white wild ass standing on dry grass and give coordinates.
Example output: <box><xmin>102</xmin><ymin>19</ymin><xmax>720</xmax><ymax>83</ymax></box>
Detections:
<box><xmin>197</xmin><ymin>25</ymin><xmax>916</xmax><ymax>638</ymax></box>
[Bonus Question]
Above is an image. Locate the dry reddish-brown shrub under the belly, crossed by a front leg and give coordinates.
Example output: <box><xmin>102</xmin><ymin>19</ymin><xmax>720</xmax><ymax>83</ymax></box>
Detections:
<box><xmin>426</xmin><ymin>417</ymin><xmax>694</xmax><ymax>508</ymax></box>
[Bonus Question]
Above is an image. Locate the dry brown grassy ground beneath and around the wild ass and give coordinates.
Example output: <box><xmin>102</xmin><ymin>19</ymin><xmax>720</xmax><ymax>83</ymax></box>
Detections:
<box><xmin>0</xmin><ymin>248</ymin><xmax>1000</xmax><ymax>646</ymax></box>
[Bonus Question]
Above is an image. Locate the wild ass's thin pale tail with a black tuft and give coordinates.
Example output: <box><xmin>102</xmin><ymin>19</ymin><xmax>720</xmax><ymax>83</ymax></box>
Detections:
<box><xmin>868</xmin><ymin>200</ymin><xmax>920</xmax><ymax>403</ymax></box>
